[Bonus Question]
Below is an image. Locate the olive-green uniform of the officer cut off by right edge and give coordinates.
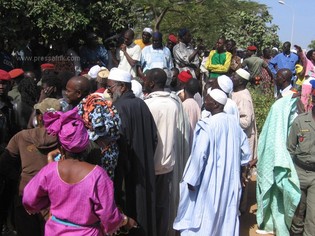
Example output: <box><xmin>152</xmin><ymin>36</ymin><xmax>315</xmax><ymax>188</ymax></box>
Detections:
<box><xmin>287</xmin><ymin>106</ymin><xmax>315</xmax><ymax>236</ymax></box>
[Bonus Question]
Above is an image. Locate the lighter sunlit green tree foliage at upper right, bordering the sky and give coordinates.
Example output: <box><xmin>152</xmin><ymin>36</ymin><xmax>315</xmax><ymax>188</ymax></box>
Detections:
<box><xmin>133</xmin><ymin>0</ymin><xmax>279</xmax><ymax>48</ymax></box>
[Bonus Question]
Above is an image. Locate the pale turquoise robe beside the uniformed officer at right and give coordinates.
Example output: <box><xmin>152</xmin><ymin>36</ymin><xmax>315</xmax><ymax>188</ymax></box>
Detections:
<box><xmin>256</xmin><ymin>95</ymin><xmax>301</xmax><ymax>236</ymax></box>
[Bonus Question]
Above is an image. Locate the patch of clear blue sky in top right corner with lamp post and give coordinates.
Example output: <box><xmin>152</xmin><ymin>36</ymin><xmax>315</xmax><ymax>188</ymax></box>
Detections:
<box><xmin>256</xmin><ymin>0</ymin><xmax>315</xmax><ymax>49</ymax></box>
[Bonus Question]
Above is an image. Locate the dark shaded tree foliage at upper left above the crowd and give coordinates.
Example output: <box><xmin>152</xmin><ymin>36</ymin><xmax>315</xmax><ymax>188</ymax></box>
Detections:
<box><xmin>0</xmin><ymin>0</ymin><xmax>134</xmax><ymax>48</ymax></box>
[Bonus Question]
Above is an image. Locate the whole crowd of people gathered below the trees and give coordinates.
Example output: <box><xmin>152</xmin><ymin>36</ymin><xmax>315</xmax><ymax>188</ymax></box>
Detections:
<box><xmin>0</xmin><ymin>28</ymin><xmax>315</xmax><ymax>236</ymax></box>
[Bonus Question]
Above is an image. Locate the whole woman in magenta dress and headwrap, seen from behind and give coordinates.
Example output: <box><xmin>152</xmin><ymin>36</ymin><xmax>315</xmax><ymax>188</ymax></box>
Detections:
<box><xmin>23</xmin><ymin>109</ymin><xmax>136</xmax><ymax>236</ymax></box>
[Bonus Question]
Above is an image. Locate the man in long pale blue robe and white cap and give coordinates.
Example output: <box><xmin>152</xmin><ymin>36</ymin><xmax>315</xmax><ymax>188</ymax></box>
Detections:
<box><xmin>173</xmin><ymin>89</ymin><xmax>250</xmax><ymax>236</ymax></box>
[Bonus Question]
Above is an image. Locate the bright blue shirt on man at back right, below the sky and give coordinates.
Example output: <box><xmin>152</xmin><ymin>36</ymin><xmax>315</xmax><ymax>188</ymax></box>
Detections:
<box><xmin>268</xmin><ymin>52</ymin><xmax>299</xmax><ymax>75</ymax></box>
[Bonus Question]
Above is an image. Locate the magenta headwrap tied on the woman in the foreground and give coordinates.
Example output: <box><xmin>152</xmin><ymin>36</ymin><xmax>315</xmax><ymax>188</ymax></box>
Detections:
<box><xmin>44</xmin><ymin>109</ymin><xmax>89</xmax><ymax>153</ymax></box>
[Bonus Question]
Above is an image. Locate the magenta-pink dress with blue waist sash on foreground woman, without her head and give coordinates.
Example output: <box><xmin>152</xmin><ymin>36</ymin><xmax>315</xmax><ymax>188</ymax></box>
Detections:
<box><xmin>23</xmin><ymin>162</ymin><xmax>123</xmax><ymax>236</ymax></box>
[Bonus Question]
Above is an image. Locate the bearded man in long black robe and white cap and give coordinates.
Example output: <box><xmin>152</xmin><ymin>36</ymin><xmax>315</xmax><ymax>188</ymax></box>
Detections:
<box><xmin>107</xmin><ymin>68</ymin><xmax>157</xmax><ymax>236</ymax></box>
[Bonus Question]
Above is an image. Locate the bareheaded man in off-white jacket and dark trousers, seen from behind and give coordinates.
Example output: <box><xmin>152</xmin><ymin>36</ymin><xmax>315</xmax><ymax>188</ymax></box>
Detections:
<box><xmin>144</xmin><ymin>68</ymin><xmax>189</xmax><ymax>236</ymax></box>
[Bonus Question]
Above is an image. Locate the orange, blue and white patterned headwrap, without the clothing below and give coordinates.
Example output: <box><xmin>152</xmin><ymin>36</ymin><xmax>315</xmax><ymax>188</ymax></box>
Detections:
<box><xmin>78</xmin><ymin>93</ymin><xmax>121</xmax><ymax>141</ymax></box>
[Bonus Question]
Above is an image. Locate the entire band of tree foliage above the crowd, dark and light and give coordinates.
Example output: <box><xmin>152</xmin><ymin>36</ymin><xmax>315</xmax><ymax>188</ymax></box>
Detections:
<box><xmin>0</xmin><ymin>0</ymin><xmax>279</xmax><ymax>52</ymax></box>
